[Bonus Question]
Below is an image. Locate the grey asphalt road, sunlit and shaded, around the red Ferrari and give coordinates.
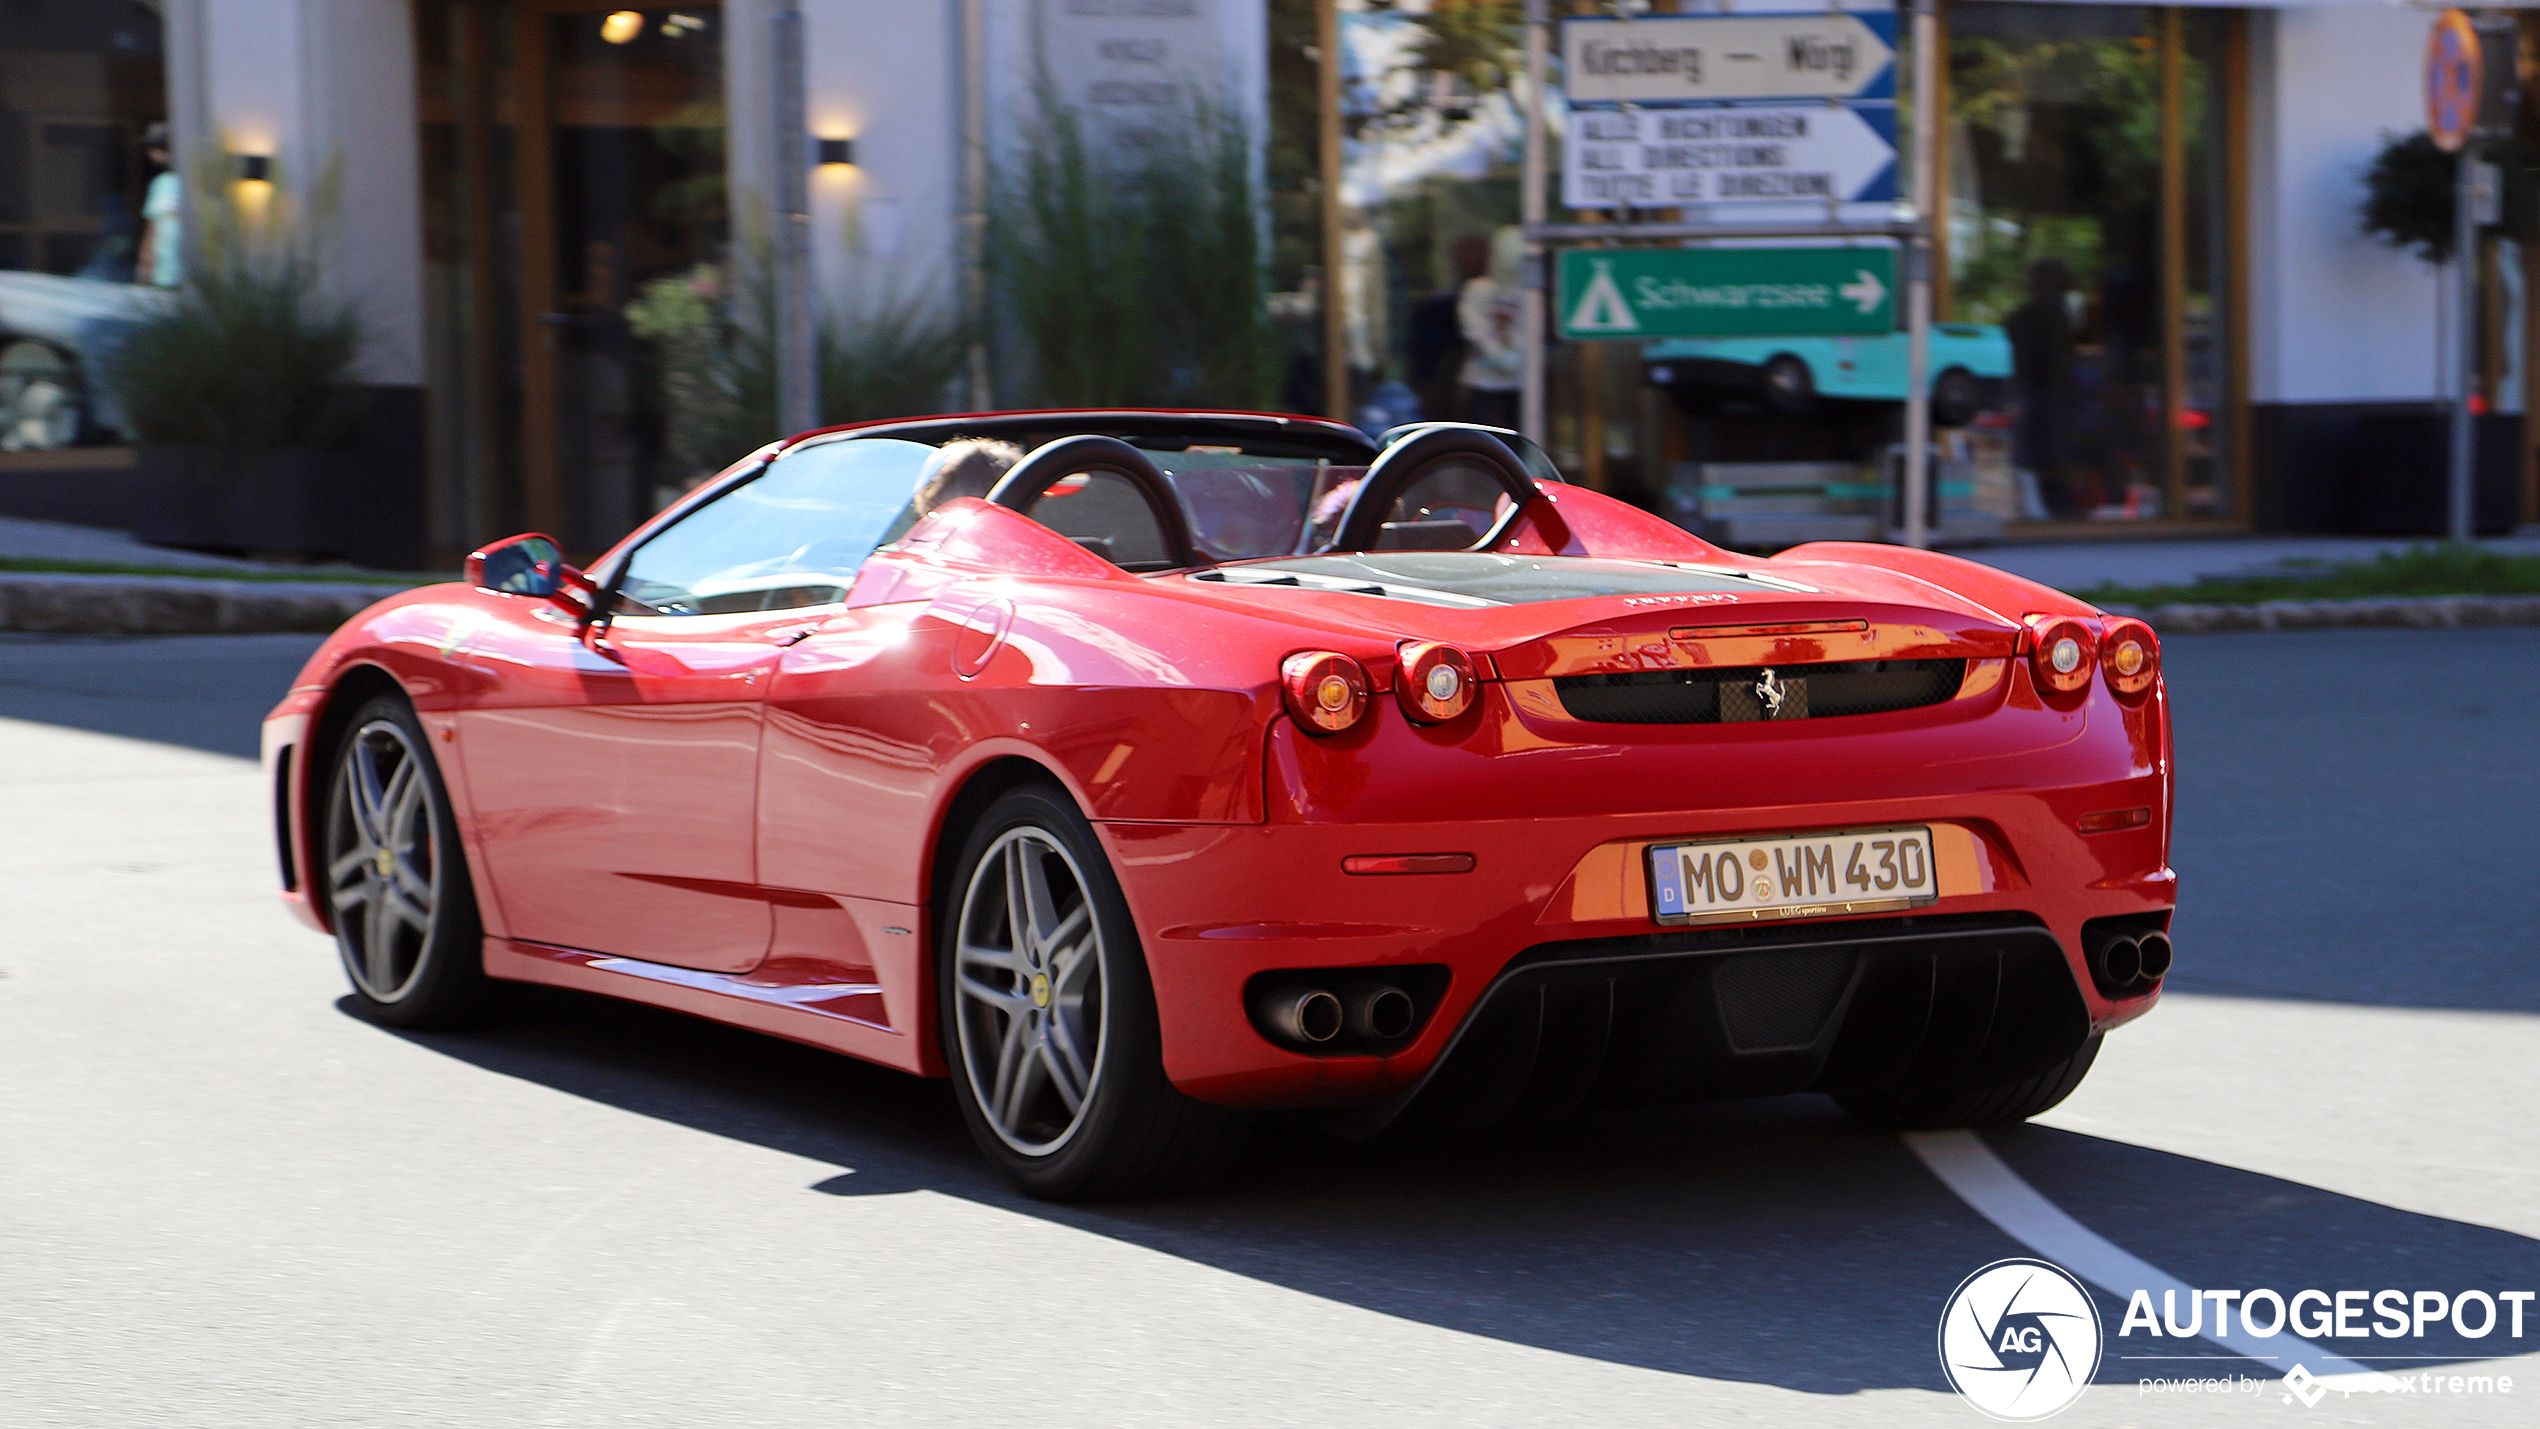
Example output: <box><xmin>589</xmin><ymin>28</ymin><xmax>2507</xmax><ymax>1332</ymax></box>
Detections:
<box><xmin>0</xmin><ymin>629</ymin><xmax>2540</xmax><ymax>1429</ymax></box>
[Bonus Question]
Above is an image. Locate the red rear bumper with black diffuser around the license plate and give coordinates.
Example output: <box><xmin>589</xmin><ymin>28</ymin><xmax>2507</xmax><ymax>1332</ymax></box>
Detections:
<box><xmin>1102</xmin><ymin>777</ymin><xmax>2174</xmax><ymax>1119</ymax></box>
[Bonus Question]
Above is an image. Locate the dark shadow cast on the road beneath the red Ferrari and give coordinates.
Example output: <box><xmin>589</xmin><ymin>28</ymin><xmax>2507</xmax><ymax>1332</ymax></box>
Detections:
<box><xmin>340</xmin><ymin>987</ymin><xmax>2540</xmax><ymax>1393</ymax></box>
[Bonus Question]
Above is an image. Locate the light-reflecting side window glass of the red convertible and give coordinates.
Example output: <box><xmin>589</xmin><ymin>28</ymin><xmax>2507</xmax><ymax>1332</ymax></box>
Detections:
<box><xmin>620</xmin><ymin>439</ymin><xmax>935</xmax><ymax>614</ymax></box>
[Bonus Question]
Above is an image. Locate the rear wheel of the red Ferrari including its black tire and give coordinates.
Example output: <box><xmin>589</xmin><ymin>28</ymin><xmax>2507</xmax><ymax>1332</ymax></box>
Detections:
<box><xmin>935</xmin><ymin>784</ymin><xmax>1252</xmax><ymax>1201</ymax></box>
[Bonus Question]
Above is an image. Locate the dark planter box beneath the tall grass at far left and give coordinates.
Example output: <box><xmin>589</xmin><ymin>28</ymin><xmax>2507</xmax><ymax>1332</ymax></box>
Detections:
<box><xmin>132</xmin><ymin>444</ymin><xmax>353</xmax><ymax>558</ymax></box>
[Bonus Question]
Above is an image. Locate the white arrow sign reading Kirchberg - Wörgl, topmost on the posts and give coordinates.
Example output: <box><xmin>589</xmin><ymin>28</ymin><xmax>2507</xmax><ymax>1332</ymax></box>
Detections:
<box><xmin>1562</xmin><ymin>10</ymin><xmax>1897</xmax><ymax>104</ymax></box>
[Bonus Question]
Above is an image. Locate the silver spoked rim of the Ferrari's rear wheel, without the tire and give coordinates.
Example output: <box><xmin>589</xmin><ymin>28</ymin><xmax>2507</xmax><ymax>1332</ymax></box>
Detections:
<box><xmin>953</xmin><ymin>825</ymin><xmax>1107</xmax><ymax>1155</ymax></box>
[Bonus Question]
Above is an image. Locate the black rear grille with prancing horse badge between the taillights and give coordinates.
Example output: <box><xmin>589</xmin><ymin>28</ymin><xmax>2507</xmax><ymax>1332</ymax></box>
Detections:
<box><xmin>1552</xmin><ymin>660</ymin><xmax>1966</xmax><ymax>723</ymax></box>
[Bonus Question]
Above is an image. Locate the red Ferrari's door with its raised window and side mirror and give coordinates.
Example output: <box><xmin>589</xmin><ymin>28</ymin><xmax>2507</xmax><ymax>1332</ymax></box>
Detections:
<box><xmin>460</xmin><ymin>442</ymin><xmax>930</xmax><ymax>972</ymax></box>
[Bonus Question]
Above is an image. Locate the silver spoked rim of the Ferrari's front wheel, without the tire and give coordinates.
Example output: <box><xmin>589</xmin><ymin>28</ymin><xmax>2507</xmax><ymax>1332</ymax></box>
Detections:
<box><xmin>325</xmin><ymin>718</ymin><xmax>439</xmax><ymax>1003</ymax></box>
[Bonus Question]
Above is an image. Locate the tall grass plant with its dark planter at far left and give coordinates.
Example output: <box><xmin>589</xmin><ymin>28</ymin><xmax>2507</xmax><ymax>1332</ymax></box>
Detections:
<box><xmin>107</xmin><ymin>158</ymin><xmax>361</xmax><ymax>558</ymax></box>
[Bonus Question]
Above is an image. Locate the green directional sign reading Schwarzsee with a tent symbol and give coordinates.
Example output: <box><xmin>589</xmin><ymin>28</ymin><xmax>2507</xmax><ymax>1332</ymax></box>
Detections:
<box><xmin>1557</xmin><ymin>249</ymin><xmax>1897</xmax><ymax>338</ymax></box>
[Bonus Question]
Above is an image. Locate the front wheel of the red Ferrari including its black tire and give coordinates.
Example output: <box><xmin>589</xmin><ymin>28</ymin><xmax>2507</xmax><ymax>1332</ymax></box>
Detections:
<box><xmin>310</xmin><ymin>695</ymin><xmax>490</xmax><ymax>1028</ymax></box>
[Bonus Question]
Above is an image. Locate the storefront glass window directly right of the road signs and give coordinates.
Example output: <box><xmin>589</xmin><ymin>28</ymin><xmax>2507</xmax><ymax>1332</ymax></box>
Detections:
<box><xmin>1946</xmin><ymin>0</ymin><xmax>2230</xmax><ymax>520</ymax></box>
